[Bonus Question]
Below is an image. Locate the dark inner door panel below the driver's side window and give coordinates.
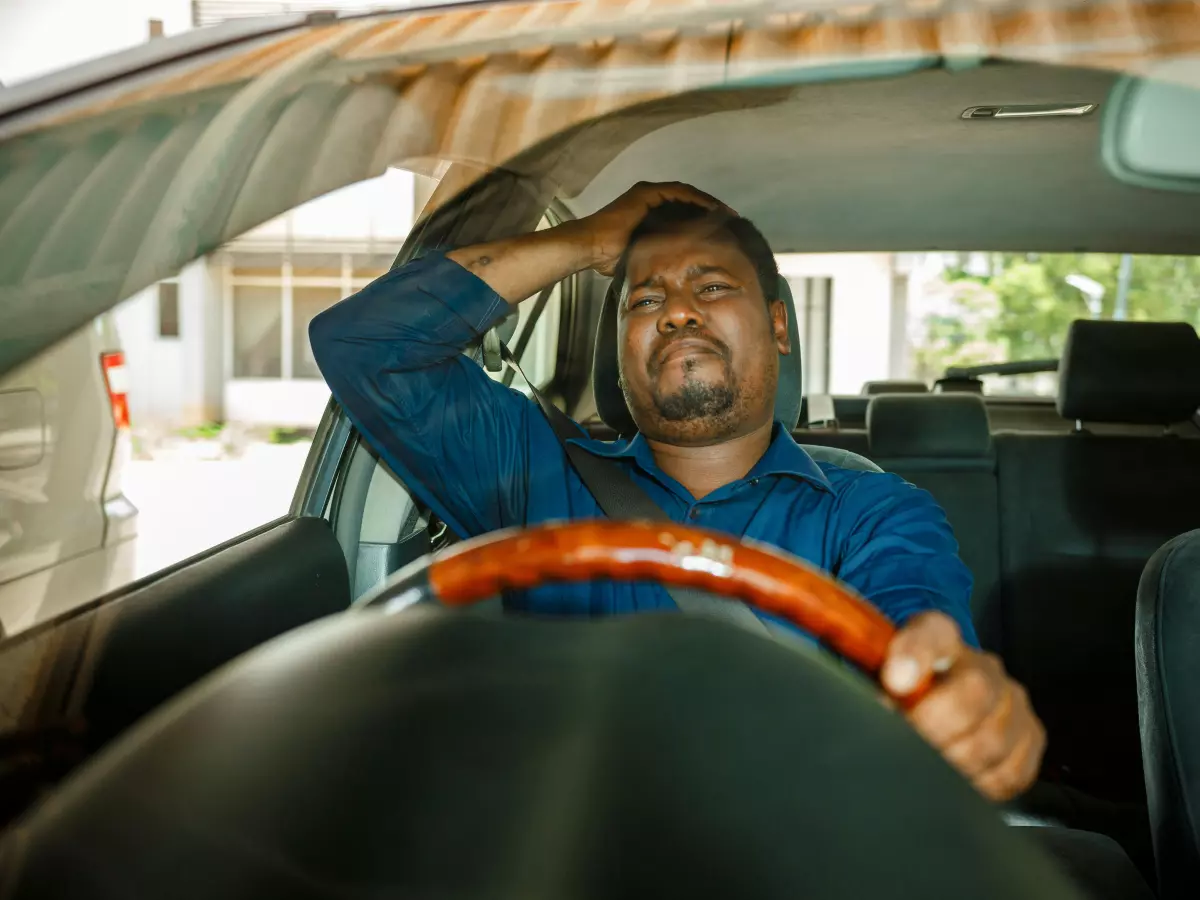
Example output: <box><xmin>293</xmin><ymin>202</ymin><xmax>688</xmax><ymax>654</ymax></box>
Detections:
<box><xmin>0</xmin><ymin>427</ymin><xmax>350</xmax><ymax>830</ymax></box>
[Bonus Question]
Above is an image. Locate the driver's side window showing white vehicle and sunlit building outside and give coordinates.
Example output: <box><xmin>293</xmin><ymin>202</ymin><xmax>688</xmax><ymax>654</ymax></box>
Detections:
<box><xmin>0</xmin><ymin>169</ymin><xmax>429</xmax><ymax>635</ymax></box>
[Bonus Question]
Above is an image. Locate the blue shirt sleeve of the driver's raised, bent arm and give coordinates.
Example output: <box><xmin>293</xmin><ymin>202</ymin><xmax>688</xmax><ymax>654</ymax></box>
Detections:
<box><xmin>308</xmin><ymin>253</ymin><xmax>560</xmax><ymax>538</ymax></box>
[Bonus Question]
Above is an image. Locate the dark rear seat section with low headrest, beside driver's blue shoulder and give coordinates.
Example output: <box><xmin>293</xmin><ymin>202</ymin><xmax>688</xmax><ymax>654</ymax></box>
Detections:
<box><xmin>866</xmin><ymin>394</ymin><xmax>1002</xmax><ymax>652</ymax></box>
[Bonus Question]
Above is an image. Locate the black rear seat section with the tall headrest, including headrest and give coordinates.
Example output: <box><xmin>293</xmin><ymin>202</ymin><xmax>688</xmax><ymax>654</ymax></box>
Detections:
<box><xmin>994</xmin><ymin>322</ymin><xmax>1200</xmax><ymax>803</ymax></box>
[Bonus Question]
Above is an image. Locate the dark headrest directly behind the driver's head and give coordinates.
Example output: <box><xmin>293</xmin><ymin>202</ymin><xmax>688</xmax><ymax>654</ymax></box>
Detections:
<box><xmin>592</xmin><ymin>278</ymin><xmax>804</xmax><ymax>434</ymax></box>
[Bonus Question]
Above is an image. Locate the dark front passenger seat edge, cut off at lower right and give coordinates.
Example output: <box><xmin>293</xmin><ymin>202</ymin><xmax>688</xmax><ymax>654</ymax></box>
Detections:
<box><xmin>1135</xmin><ymin>530</ymin><xmax>1200</xmax><ymax>900</ymax></box>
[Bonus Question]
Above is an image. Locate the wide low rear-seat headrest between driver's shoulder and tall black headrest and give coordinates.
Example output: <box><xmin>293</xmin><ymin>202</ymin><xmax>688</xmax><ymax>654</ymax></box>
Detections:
<box><xmin>866</xmin><ymin>394</ymin><xmax>991</xmax><ymax>460</ymax></box>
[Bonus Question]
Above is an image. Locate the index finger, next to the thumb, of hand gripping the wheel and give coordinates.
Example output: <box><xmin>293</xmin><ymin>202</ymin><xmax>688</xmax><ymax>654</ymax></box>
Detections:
<box><xmin>907</xmin><ymin>654</ymin><xmax>1007</xmax><ymax>750</ymax></box>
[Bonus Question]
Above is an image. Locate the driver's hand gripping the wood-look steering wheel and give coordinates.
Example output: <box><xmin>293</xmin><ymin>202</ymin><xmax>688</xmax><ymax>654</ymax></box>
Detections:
<box><xmin>881</xmin><ymin>612</ymin><xmax>1046</xmax><ymax>800</ymax></box>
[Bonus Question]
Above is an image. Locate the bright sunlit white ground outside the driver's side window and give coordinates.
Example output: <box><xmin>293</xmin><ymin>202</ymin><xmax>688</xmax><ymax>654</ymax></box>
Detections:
<box><xmin>124</xmin><ymin>440</ymin><xmax>310</xmax><ymax>577</ymax></box>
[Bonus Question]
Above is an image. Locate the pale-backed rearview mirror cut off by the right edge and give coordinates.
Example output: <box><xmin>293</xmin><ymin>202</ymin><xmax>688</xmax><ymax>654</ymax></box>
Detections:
<box><xmin>1102</xmin><ymin>58</ymin><xmax>1200</xmax><ymax>192</ymax></box>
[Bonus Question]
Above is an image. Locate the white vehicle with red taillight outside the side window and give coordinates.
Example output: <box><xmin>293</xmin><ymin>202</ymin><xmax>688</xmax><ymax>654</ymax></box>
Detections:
<box><xmin>0</xmin><ymin>314</ymin><xmax>137</xmax><ymax>634</ymax></box>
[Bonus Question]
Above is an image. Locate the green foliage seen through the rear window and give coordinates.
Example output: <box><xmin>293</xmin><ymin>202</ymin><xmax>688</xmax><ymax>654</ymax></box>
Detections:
<box><xmin>914</xmin><ymin>253</ymin><xmax>1200</xmax><ymax>379</ymax></box>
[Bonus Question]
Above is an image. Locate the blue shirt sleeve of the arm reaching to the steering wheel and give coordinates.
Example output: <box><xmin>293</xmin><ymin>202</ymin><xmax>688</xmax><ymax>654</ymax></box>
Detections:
<box><xmin>834</xmin><ymin>473</ymin><xmax>979</xmax><ymax>647</ymax></box>
